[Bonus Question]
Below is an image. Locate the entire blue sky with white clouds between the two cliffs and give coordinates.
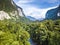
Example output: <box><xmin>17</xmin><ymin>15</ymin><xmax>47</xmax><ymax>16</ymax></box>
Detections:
<box><xmin>14</xmin><ymin>0</ymin><xmax>60</xmax><ymax>19</ymax></box>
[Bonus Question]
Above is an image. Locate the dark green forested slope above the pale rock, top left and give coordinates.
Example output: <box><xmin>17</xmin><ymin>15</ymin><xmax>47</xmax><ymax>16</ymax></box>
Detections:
<box><xmin>0</xmin><ymin>0</ymin><xmax>16</xmax><ymax>12</ymax></box>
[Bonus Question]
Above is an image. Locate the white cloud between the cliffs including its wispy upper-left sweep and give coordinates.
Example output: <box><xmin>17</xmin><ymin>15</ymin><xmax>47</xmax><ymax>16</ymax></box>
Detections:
<box><xmin>14</xmin><ymin>0</ymin><xmax>56</xmax><ymax>19</ymax></box>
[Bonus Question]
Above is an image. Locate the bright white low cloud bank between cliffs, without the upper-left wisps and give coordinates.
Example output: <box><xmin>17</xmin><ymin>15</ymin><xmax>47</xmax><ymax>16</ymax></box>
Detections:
<box><xmin>24</xmin><ymin>6</ymin><xmax>56</xmax><ymax>19</ymax></box>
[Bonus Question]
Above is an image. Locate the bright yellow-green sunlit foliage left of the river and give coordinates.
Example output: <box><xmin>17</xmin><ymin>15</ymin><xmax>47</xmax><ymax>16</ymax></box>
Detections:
<box><xmin>0</xmin><ymin>20</ymin><xmax>30</xmax><ymax>45</ymax></box>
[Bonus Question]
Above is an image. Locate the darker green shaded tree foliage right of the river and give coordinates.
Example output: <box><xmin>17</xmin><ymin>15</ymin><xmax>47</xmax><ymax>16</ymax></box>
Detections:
<box><xmin>26</xmin><ymin>19</ymin><xmax>60</xmax><ymax>45</ymax></box>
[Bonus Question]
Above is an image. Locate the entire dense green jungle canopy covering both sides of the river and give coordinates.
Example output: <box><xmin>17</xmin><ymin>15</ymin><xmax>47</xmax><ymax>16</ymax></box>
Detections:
<box><xmin>0</xmin><ymin>19</ymin><xmax>60</xmax><ymax>45</ymax></box>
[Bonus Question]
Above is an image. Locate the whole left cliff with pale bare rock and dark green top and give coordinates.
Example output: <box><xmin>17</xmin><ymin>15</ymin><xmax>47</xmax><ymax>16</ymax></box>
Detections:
<box><xmin>0</xmin><ymin>0</ymin><xmax>25</xmax><ymax>20</ymax></box>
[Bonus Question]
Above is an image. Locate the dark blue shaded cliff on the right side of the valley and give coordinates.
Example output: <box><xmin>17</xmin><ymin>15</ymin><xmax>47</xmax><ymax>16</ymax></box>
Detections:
<box><xmin>46</xmin><ymin>5</ymin><xmax>60</xmax><ymax>20</ymax></box>
